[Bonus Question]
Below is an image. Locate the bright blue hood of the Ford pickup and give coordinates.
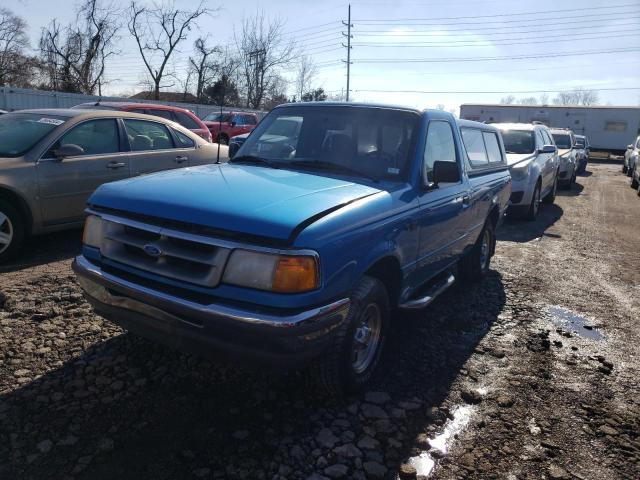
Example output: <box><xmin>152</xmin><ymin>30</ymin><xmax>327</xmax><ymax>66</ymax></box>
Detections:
<box><xmin>89</xmin><ymin>164</ymin><xmax>380</xmax><ymax>240</ymax></box>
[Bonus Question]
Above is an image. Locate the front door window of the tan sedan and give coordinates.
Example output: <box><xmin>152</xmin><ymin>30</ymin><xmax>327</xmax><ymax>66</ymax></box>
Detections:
<box><xmin>45</xmin><ymin>119</ymin><xmax>120</xmax><ymax>158</ymax></box>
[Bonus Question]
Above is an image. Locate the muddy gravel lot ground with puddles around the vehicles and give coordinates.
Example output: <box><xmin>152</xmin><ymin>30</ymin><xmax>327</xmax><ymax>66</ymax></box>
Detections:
<box><xmin>0</xmin><ymin>164</ymin><xmax>640</xmax><ymax>480</ymax></box>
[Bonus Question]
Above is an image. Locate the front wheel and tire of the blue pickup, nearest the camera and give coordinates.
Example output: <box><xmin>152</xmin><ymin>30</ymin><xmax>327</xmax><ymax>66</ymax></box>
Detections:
<box><xmin>307</xmin><ymin>276</ymin><xmax>390</xmax><ymax>396</ymax></box>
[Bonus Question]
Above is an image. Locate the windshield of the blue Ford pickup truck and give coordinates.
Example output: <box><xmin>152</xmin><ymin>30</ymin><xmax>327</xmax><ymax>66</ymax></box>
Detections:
<box><xmin>233</xmin><ymin>106</ymin><xmax>420</xmax><ymax>181</ymax></box>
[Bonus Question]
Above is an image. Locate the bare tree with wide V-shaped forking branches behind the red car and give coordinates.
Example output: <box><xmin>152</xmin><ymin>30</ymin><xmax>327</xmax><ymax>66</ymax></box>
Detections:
<box><xmin>128</xmin><ymin>0</ymin><xmax>211</xmax><ymax>100</ymax></box>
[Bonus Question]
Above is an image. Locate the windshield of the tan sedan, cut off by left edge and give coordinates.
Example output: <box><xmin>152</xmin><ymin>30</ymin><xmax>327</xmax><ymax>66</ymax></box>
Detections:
<box><xmin>0</xmin><ymin>113</ymin><xmax>68</xmax><ymax>157</ymax></box>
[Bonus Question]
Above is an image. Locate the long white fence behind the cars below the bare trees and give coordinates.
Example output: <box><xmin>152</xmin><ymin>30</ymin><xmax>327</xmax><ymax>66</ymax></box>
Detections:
<box><xmin>0</xmin><ymin>87</ymin><xmax>266</xmax><ymax>118</ymax></box>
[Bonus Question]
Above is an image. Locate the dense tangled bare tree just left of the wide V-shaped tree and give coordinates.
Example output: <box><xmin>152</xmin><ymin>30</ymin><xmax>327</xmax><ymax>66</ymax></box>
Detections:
<box><xmin>40</xmin><ymin>0</ymin><xmax>120</xmax><ymax>94</ymax></box>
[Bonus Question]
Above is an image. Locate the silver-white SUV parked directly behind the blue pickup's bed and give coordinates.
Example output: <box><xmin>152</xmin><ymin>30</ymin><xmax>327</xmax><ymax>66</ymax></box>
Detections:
<box><xmin>490</xmin><ymin>123</ymin><xmax>560</xmax><ymax>220</ymax></box>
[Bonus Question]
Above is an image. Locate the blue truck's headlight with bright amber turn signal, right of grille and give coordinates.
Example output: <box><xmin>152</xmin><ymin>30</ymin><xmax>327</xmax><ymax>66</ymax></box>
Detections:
<box><xmin>222</xmin><ymin>250</ymin><xmax>320</xmax><ymax>293</ymax></box>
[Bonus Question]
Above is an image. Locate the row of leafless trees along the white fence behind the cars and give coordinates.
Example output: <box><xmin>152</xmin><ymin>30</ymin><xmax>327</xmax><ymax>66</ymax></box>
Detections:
<box><xmin>0</xmin><ymin>0</ymin><xmax>327</xmax><ymax>109</ymax></box>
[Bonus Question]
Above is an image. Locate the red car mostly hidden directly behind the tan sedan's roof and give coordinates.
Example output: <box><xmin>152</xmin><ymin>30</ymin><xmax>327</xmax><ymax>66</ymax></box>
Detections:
<box><xmin>73</xmin><ymin>102</ymin><xmax>211</xmax><ymax>142</ymax></box>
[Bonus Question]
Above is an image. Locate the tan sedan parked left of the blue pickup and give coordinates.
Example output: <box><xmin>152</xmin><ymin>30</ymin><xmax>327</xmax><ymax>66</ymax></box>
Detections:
<box><xmin>0</xmin><ymin>109</ymin><xmax>227</xmax><ymax>261</ymax></box>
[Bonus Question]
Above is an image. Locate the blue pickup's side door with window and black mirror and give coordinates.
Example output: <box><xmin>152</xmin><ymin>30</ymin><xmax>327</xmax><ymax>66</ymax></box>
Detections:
<box><xmin>412</xmin><ymin>120</ymin><xmax>470</xmax><ymax>284</ymax></box>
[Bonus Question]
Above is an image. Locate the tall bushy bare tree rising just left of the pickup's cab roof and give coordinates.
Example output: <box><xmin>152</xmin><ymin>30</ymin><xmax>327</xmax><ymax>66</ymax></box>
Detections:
<box><xmin>236</xmin><ymin>12</ymin><xmax>295</xmax><ymax>108</ymax></box>
